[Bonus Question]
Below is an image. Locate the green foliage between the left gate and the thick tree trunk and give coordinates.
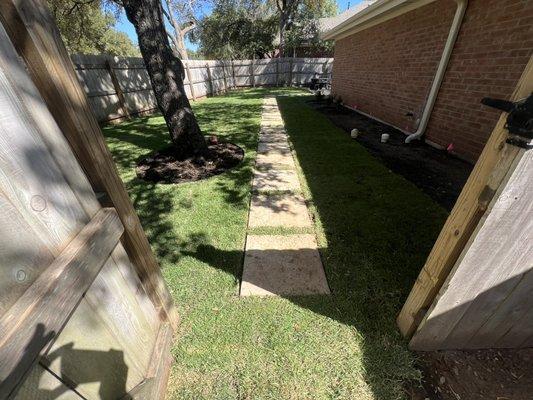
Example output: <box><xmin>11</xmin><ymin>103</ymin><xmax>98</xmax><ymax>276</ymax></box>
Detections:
<box><xmin>47</xmin><ymin>0</ymin><xmax>140</xmax><ymax>56</ymax></box>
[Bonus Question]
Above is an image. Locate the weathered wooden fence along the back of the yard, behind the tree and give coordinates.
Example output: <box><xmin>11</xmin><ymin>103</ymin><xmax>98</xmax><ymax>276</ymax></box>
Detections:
<box><xmin>72</xmin><ymin>54</ymin><xmax>333</xmax><ymax>122</ymax></box>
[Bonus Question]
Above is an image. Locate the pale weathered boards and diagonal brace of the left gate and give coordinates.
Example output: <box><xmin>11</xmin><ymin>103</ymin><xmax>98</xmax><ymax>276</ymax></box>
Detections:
<box><xmin>0</xmin><ymin>27</ymin><xmax>160</xmax><ymax>398</ymax></box>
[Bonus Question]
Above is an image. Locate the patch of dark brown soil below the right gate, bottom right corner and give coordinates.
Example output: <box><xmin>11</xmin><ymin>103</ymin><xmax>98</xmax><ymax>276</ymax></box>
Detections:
<box><xmin>412</xmin><ymin>349</ymin><xmax>533</xmax><ymax>400</ymax></box>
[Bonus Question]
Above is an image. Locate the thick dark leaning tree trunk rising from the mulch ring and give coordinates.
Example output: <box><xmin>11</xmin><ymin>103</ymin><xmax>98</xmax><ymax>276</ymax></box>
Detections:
<box><xmin>122</xmin><ymin>0</ymin><xmax>207</xmax><ymax>157</ymax></box>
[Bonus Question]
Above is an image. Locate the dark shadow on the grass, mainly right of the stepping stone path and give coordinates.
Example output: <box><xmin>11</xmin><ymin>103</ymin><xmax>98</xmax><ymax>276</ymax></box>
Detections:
<box><xmin>177</xmin><ymin>93</ymin><xmax>446</xmax><ymax>400</ymax></box>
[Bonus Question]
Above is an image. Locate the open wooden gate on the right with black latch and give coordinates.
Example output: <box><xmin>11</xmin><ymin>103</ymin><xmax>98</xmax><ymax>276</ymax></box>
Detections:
<box><xmin>398</xmin><ymin>57</ymin><xmax>533</xmax><ymax>350</ymax></box>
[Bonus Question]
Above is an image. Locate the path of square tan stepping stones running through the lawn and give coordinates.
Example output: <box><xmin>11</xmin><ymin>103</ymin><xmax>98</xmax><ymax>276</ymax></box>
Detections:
<box><xmin>240</xmin><ymin>97</ymin><xmax>330</xmax><ymax>296</ymax></box>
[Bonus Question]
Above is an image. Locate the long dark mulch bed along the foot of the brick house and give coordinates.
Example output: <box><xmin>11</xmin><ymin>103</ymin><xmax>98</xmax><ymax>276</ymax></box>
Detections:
<box><xmin>308</xmin><ymin>100</ymin><xmax>473</xmax><ymax>211</ymax></box>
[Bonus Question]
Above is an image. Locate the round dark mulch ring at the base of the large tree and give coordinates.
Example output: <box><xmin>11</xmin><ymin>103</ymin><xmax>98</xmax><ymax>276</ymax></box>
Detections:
<box><xmin>136</xmin><ymin>142</ymin><xmax>244</xmax><ymax>183</ymax></box>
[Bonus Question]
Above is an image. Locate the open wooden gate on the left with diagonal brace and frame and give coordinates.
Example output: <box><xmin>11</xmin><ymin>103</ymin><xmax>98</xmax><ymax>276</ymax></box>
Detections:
<box><xmin>0</xmin><ymin>1</ymin><xmax>176</xmax><ymax>400</ymax></box>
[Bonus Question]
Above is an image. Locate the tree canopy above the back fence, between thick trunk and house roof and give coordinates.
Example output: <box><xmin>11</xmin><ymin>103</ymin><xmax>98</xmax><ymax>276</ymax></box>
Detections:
<box><xmin>191</xmin><ymin>0</ymin><xmax>337</xmax><ymax>59</ymax></box>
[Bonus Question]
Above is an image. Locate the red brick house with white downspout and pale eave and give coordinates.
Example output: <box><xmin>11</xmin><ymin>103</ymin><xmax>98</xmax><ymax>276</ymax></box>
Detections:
<box><xmin>323</xmin><ymin>0</ymin><xmax>533</xmax><ymax>162</ymax></box>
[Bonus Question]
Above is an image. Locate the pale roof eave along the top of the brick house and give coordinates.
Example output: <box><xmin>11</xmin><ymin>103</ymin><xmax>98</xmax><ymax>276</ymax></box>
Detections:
<box><xmin>321</xmin><ymin>0</ymin><xmax>436</xmax><ymax>40</ymax></box>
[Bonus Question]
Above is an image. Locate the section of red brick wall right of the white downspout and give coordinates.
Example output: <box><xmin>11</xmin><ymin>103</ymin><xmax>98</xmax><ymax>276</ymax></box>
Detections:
<box><xmin>426</xmin><ymin>0</ymin><xmax>533</xmax><ymax>161</ymax></box>
